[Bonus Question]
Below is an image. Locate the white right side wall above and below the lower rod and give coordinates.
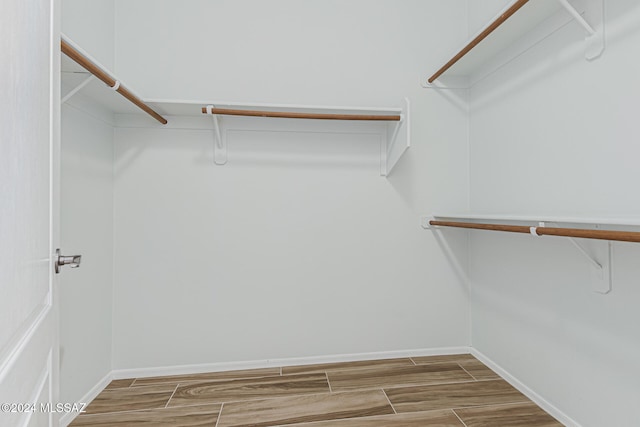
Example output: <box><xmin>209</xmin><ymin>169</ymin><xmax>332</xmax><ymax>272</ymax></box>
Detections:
<box><xmin>470</xmin><ymin>0</ymin><xmax>640</xmax><ymax>426</ymax></box>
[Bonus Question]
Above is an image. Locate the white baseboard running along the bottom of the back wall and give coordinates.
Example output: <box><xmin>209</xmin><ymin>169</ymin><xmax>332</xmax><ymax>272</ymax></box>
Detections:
<box><xmin>111</xmin><ymin>347</ymin><xmax>471</xmax><ymax>379</ymax></box>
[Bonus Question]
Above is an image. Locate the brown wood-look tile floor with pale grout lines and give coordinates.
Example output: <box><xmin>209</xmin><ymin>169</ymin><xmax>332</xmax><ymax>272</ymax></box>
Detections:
<box><xmin>71</xmin><ymin>354</ymin><xmax>562</xmax><ymax>427</ymax></box>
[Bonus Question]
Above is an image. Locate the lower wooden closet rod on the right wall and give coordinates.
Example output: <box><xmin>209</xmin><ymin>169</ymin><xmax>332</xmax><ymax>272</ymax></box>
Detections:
<box><xmin>429</xmin><ymin>220</ymin><xmax>640</xmax><ymax>243</ymax></box>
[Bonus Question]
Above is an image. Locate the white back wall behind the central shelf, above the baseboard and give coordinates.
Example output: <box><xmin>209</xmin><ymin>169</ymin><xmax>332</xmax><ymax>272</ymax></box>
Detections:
<box><xmin>114</xmin><ymin>0</ymin><xmax>469</xmax><ymax>369</ymax></box>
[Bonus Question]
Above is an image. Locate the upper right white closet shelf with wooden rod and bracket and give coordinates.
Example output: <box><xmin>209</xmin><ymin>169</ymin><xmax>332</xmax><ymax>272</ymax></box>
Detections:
<box><xmin>424</xmin><ymin>0</ymin><xmax>604</xmax><ymax>87</ymax></box>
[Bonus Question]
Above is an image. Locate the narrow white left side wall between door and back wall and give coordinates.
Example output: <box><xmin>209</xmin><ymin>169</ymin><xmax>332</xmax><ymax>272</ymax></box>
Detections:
<box><xmin>60</xmin><ymin>0</ymin><xmax>114</xmax><ymax>408</ymax></box>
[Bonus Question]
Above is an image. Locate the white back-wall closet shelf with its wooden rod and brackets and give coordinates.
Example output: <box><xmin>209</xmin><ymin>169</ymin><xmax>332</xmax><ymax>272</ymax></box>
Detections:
<box><xmin>148</xmin><ymin>98</ymin><xmax>411</xmax><ymax>176</ymax></box>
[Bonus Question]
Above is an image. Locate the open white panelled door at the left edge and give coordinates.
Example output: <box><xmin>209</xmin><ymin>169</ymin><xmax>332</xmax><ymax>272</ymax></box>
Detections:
<box><xmin>0</xmin><ymin>0</ymin><xmax>60</xmax><ymax>426</ymax></box>
